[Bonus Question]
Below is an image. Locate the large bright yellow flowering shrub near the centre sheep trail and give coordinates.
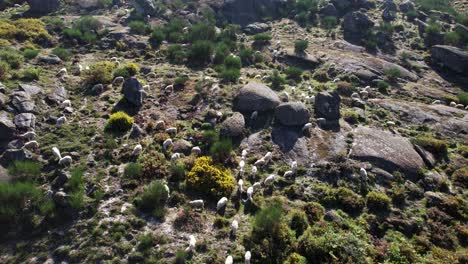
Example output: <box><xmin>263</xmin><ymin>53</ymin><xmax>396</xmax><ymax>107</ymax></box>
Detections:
<box><xmin>186</xmin><ymin>156</ymin><xmax>235</xmax><ymax>197</ymax></box>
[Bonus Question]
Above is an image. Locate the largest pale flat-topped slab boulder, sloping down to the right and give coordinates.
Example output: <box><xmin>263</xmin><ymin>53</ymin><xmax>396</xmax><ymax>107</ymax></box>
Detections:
<box><xmin>351</xmin><ymin>127</ymin><xmax>424</xmax><ymax>176</ymax></box>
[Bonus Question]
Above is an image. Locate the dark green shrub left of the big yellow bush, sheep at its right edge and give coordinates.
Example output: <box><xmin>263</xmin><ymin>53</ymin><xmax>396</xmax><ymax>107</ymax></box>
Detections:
<box><xmin>134</xmin><ymin>181</ymin><xmax>169</xmax><ymax>220</ymax></box>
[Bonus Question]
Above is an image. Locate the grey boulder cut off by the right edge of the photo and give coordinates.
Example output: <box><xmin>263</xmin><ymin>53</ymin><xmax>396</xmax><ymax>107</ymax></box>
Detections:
<box><xmin>431</xmin><ymin>45</ymin><xmax>468</xmax><ymax>74</ymax></box>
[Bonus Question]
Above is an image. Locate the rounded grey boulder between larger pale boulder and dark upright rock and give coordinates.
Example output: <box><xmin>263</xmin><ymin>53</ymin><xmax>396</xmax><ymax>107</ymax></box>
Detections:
<box><xmin>275</xmin><ymin>102</ymin><xmax>310</xmax><ymax>126</ymax></box>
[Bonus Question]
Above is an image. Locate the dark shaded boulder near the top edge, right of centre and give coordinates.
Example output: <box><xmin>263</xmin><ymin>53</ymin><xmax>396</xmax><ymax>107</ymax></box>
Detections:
<box><xmin>343</xmin><ymin>11</ymin><xmax>374</xmax><ymax>44</ymax></box>
